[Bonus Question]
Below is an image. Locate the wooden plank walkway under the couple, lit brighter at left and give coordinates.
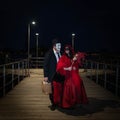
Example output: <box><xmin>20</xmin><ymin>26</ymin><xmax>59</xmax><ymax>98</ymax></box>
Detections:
<box><xmin>0</xmin><ymin>69</ymin><xmax>120</xmax><ymax>120</ymax></box>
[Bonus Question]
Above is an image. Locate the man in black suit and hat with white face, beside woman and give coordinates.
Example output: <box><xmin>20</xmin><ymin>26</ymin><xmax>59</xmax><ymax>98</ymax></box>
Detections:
<box><xmin>44</xmin><ymin>39</ymin><xmax>61</xmax><ymax>111</ymax></box>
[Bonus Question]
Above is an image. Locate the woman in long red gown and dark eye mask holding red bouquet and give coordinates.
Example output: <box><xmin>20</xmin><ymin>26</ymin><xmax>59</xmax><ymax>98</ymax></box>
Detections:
<box><xmin>54</xmin><ymin>45</ymin><xmax>88</xmax><ymax>108</ymax></box>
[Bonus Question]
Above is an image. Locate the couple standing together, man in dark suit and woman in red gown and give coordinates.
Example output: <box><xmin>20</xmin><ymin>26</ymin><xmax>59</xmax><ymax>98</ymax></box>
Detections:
<box><xmin>44</xmin><ymin>39</ymin><xmax>88</xmax><ymax>110</ymax></box>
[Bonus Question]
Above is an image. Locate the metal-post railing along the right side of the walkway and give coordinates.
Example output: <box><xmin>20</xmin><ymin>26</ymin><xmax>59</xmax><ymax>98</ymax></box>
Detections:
<box><xmin>84</xmin><ymin>60</ymin><xmax>120</xmax><ymax>96</ymax></box>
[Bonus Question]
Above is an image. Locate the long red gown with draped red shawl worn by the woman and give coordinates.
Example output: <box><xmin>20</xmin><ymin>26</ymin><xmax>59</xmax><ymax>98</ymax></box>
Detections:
<box><xmin>53</xmin><ymin>55</ymin><xmax>88</xmax><ymax>108</ymax></box>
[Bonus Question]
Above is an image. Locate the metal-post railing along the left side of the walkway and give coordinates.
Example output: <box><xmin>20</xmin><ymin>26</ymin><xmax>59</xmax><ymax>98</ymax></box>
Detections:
<box><xmin>0</xmin><ymin>59</ymin><xmax>28</xmax><ymax>96</ymax></box>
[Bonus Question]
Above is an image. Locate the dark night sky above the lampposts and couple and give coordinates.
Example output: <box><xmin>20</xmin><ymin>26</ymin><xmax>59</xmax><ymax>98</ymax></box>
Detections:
<box><xmin>0</xmin><ymin>0</ymin><xmax>120</xmax><ymax>51</ymax></box>
